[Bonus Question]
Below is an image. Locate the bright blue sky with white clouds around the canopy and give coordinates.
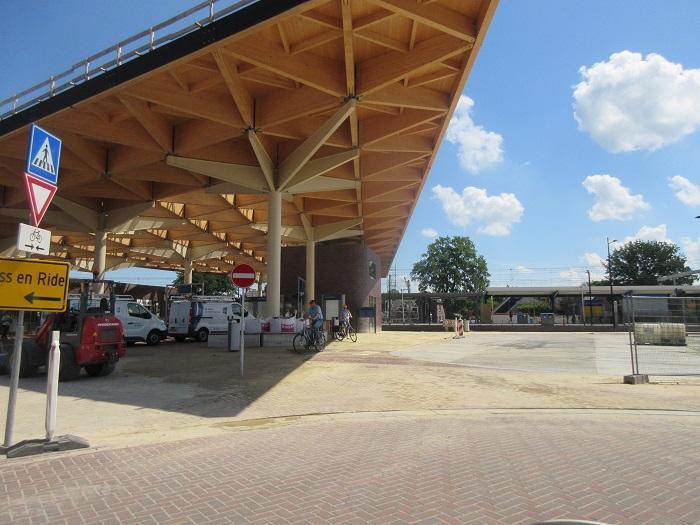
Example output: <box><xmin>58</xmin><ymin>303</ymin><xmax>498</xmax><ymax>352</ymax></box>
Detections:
<box><xmin>0</xmin><ymin>0</ymin><xmax>700</xmax><ymax>284</ymax></box>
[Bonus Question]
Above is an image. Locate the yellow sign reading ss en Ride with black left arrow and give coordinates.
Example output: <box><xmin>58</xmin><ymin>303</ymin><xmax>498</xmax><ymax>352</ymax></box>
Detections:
<box><xmin>0</xmin><ymin>257</ymin><xmax>70</xmax><ymax>312</ymax></box>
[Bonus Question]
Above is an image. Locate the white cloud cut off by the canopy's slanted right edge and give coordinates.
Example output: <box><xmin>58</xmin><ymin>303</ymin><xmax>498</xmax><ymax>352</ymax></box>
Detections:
<box><xmin>445</xmin><ymin>95</ymin><xmax>503</xmax><ymax>173</ymax></box>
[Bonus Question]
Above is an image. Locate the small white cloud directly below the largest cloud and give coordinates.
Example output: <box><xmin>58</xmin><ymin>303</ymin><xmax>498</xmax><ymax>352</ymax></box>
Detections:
<box><xmin>582</xmin><ymin>175</ymin><xmax>649</xmax><ymax>222</ymax></box>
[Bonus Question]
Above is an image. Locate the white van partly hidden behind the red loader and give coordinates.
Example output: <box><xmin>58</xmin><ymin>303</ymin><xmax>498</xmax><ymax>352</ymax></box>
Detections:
<box><xmin>68</xmin><ymin>294</ymin><xmax>168</xmax><ymax>345</ymax></box>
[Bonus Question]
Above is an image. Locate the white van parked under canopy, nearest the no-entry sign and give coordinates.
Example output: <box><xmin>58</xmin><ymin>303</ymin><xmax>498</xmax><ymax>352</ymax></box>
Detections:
<box><xmin>168</xmin><ymin>296</ymin><xmax>254</xmax><ymax>342</ymax></box>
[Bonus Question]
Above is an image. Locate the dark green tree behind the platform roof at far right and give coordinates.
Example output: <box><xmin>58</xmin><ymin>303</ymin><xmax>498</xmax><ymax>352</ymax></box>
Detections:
<box><xmin>604</xmin><ymin>240</ymin><xmax>695</xmax><ymax>285</ymax></box>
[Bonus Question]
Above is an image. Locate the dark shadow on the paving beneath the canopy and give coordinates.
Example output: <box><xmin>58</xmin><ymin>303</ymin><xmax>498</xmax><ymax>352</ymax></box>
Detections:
<box><xmin>0</xmin><ymin>341</ymin><xmax>318</xmax><ymax>417</ymax></box>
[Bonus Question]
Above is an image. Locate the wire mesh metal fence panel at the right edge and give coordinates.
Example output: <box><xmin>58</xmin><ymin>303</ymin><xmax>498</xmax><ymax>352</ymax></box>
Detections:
<box><xmin>624</xmin><ymin>296</ymin><xmax>700</xmax><ymax>376</ymax></box>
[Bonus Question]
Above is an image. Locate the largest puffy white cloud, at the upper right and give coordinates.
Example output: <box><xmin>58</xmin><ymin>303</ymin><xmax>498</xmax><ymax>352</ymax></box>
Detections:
<box><xmin>574</xmin><ymin>51</ymin><xmax>700</xmax><ymax>153</ymax></box>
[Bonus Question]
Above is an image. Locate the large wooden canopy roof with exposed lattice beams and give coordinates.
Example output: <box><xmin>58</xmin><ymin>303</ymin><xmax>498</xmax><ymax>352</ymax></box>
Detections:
<box><xmin>0</xmin><ymin>0</ymin><xmax>497</xmax><ymax>272</ymax></box>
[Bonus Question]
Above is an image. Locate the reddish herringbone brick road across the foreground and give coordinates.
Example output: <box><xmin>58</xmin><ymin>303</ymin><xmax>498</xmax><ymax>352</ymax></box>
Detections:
<box><xmin>0</xmin><ymin>412</ymin><xmax>700</xmax><ymax>525</ymax></box>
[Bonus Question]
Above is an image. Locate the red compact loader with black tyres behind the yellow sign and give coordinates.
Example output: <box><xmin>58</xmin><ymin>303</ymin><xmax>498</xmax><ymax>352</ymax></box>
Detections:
<box><xmin>7</xmin><ymin>280</ymin><xmax>126</xmax><ymax>381</ymax></box>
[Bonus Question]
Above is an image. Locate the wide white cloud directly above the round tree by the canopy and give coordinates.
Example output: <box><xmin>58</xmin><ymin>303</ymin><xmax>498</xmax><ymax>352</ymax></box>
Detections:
<box><xmin>433</xmin><ymin>184</ymin><xmax>525</xmax><ymax>237</ymax></box>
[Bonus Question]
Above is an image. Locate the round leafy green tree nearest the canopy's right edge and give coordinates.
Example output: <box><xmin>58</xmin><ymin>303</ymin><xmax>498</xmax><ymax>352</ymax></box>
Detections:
<box><xmin>411</xmin><ymin>237</ymin><xmax>490</xmax><ymax>293</ymax></box>
